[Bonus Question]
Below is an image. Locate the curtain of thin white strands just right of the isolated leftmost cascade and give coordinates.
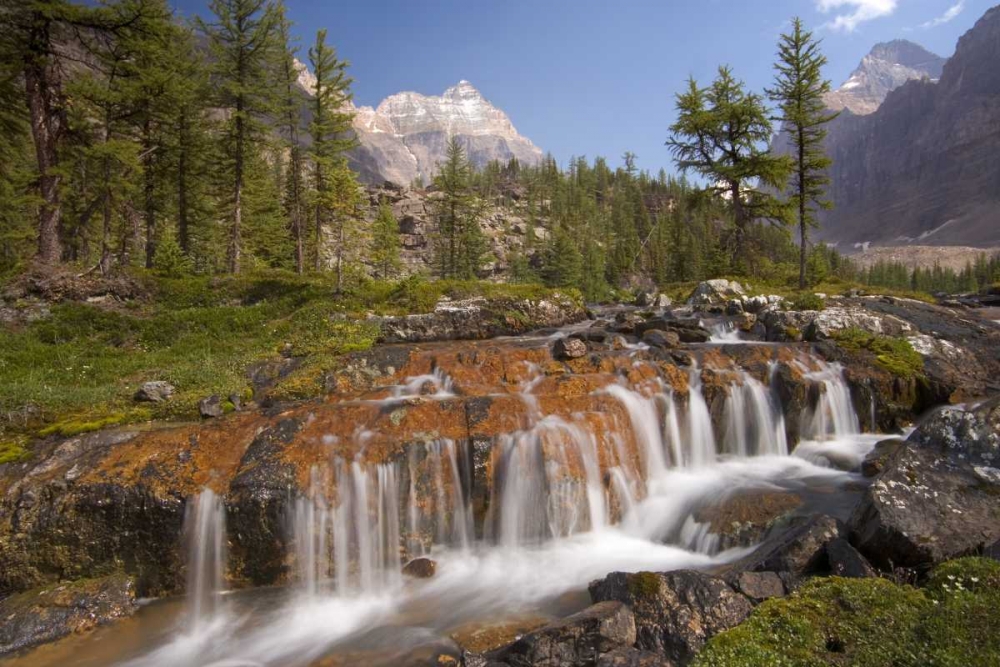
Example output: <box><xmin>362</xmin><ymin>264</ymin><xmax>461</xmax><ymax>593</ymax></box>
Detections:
<box><xmin>291</xmin><ymin>461</ymin><xmax>400</xmax><ymax>595</ymax></box>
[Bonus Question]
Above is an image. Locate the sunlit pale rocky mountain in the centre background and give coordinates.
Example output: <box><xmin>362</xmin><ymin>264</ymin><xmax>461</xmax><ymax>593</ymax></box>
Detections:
<box><xmin>351</xmin><ymin>81</ymin><xmax>542</xmax><ymax>185</ymax></box>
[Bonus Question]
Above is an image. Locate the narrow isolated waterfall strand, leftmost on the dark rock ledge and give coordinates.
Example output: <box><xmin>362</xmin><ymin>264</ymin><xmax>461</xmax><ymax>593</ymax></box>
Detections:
<box><xmin>184</xmin><ymin>489</ymin><xmax>226</xmax><ymax>633</ymax></box>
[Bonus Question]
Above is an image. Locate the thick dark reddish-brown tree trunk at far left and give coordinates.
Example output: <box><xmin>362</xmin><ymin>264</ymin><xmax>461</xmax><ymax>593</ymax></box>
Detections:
<box><xmin>24</xmin><ymin>33</ymin><xmax>64</xmax><ymax>264</ymax></box>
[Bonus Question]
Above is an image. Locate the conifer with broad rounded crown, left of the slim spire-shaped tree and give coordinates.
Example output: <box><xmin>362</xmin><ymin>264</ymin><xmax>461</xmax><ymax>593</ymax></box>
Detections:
<box><xmin>666</xmin><ymin>67</ymin><xmax>791</xmax><ymax>267</ymax></box>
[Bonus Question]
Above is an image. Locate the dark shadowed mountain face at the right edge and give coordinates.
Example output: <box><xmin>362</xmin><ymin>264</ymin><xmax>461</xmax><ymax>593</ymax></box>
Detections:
<box><xmin>820</xmin><ymin>7</ymin><xmax>1000</xmax><ymax>247</ymax></box>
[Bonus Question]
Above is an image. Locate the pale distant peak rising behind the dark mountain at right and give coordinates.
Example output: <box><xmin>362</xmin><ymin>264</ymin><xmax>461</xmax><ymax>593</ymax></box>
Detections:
<box><xmin>826</xmin><ymin>39</ymin><xmax>947</xmax><ymax>116</ymax></box>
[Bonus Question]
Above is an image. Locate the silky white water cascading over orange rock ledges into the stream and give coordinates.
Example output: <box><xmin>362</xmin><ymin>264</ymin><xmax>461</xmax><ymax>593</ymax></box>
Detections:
<box><xmin>68</xmin><ymin>334</ymin><xmax>884</xmax><ymax>667</ymax></box>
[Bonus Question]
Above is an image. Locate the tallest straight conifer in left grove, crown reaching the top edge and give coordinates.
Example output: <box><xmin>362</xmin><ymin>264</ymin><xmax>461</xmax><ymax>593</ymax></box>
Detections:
<box><xmin>199</xmin><ymin>0</ymin><xmax>277</xmax><ymax>273</ymax></box>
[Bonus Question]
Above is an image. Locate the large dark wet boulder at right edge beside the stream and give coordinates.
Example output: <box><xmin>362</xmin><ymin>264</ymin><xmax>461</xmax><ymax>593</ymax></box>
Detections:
<box><xmin>850</xmin><ymin>398</ymin><xmax>1000</xmax><ymax>569</ymax></box>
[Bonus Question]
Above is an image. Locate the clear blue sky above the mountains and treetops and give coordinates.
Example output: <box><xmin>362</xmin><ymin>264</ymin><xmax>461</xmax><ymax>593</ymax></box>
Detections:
<box><xmin>175</xmin><ymin>0</ymin><xmax>997</xmax><ymax>172</ymax></box>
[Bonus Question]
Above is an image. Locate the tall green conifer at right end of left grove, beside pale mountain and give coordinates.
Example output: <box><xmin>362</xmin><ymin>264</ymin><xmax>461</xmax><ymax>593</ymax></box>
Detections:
<box><xmin>309</xmin><ymin>30</ymin><xmax>360</xmax><ymax>284</ymax></box>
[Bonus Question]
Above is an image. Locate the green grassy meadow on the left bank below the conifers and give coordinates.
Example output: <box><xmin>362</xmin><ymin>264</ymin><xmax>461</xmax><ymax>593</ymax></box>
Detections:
<box><xmin>0</xmin><ymin>272</ymin><xmax>582</xmax><ymax>448</ymax></box>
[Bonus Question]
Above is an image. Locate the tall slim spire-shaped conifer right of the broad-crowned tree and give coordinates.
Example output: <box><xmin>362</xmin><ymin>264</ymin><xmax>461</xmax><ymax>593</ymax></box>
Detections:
<box><xmin>767</xmin><ymin>17</ymin><xmax>838</xmax><ymax>289</ymax></box>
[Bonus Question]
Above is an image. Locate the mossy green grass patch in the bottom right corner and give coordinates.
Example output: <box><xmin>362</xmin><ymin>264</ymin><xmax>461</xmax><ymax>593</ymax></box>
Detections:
<box><xmin>694</xmin><ymin>558</ymin><xmax>1000</xmax><ymax>667</ymax></box>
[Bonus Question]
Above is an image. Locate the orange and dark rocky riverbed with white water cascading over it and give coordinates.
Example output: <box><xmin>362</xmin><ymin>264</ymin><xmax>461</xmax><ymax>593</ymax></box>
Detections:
<box><xmin>0</xmin><ymin>281</ymin><xmax>1000</xmax><ymax>667</ymax></box>
